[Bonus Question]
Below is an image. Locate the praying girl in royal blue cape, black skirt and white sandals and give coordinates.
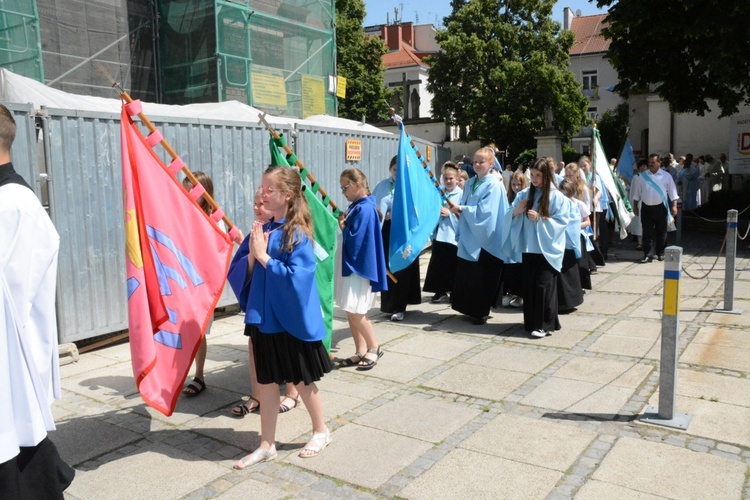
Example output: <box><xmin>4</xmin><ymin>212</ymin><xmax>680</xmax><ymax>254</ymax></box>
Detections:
<box><xmin>228</xmin><ymin>167</ymin><xmax>331</xmax><ymax>469</ymax></box>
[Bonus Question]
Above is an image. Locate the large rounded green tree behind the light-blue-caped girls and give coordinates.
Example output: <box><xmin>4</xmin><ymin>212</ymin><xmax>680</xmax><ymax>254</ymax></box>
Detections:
<box><xmin>427</xmin><ymin>0</ymin><xmax>588</xmax><ymax>151</ymax></box>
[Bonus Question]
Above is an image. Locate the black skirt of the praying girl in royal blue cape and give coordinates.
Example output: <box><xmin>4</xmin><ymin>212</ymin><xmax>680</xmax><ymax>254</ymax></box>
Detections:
<box><xmin>245</xmin><ymin>325</ymin><xmax>331</xmax><ymax>385</ymax></box>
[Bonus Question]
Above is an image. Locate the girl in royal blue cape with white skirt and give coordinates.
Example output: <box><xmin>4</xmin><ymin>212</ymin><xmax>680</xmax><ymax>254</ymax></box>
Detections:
<box><xmin>336</xmin><ymin>168</ymin><xmax>388</xmax><ymax>370</ymax></box>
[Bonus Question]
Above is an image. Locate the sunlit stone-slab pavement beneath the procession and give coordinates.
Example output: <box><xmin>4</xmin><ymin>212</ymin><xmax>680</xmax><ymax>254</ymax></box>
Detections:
<box><xmin>57</xmin><ymin>231</ymin><xmax>750</xmax><ymax>500</ymax></box>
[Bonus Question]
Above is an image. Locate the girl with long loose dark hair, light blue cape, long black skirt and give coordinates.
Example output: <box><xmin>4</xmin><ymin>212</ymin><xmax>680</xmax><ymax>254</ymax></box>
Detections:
<box><xmin>503</xmin><ymin>158</ymin><xmax>569</xmax><ymax>338</ymax></box>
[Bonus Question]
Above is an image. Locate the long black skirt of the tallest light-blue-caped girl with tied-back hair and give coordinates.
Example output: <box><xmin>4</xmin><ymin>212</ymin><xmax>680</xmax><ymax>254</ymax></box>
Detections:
<box><xmin>451</xmin><ymin>250</ymin><xmax>503</xmax><ymax>318</ymax></box>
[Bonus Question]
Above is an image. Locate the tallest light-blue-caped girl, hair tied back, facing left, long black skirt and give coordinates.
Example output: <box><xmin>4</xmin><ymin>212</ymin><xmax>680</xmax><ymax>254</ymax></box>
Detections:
<box><xmin>451</xmin><ymin>148</ymin><xmax>508</xmax><ymax>325</ymax></box>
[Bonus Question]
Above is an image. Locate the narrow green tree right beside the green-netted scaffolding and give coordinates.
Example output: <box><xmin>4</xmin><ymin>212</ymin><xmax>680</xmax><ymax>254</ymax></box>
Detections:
<box><xmin>336</xmin><ymin>0</ymin><xmax>391</xmax><ymax>122</ymax></box>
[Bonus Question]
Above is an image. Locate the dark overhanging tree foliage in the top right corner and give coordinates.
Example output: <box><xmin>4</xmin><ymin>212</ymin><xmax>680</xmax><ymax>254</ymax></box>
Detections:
<box><xmin>598</xmin><ymin>0</ymin><xmax>750</xmax><ymax>116</ymax></box>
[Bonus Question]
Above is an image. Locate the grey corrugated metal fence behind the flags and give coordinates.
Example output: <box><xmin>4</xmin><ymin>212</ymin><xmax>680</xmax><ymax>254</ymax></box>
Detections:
<box><xmin>8</xmin><ymin>104</ymin><xmax>437</xmax><ymax>343</ymax></box>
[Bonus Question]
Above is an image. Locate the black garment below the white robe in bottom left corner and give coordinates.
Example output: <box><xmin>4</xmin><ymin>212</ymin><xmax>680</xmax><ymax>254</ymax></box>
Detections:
<box><xmin>0</xmin><ymin>437</ymin><xmax>76</xmax><ymax>499</ymax></box>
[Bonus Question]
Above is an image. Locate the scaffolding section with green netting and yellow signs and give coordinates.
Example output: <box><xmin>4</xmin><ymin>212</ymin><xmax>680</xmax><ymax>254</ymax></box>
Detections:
<box><xmin>158</xmin><ymin>0</ymin><xmax>336</xmax><ymax>118</ymax></box>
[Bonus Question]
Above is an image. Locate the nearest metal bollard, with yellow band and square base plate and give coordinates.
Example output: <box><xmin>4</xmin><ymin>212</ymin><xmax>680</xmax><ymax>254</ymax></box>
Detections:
<box><xmin>641</xmin><ymin>246</ymin><xmax>693</xmax><ymax>430</ymax></box>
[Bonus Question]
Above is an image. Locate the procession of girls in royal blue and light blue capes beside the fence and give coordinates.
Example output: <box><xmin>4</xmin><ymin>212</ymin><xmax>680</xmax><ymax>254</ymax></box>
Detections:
<box><xmin>178</xmin><ymin>148</ymin><xmax>590</xmax><ymax>469</ymax></box>
